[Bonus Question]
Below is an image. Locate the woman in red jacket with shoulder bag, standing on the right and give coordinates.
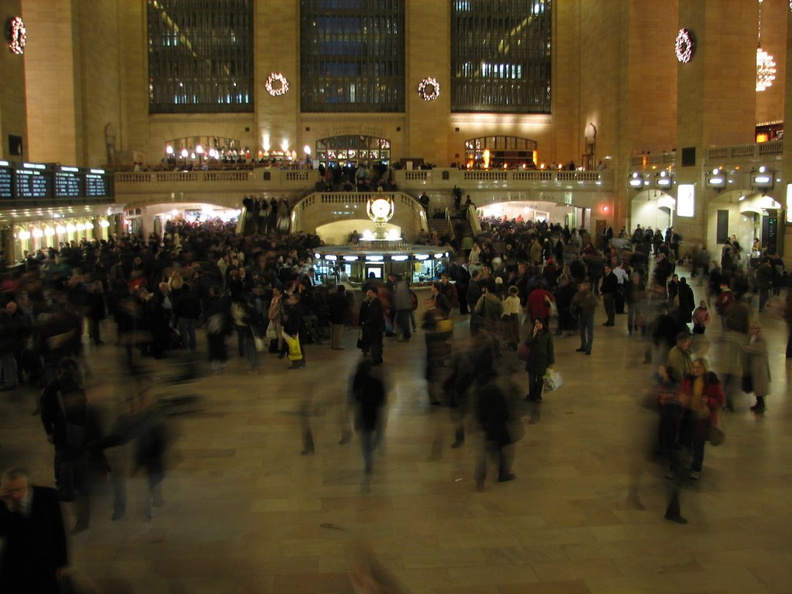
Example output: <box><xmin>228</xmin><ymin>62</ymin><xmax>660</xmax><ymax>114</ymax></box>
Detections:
<box><xmin>680</xmin><ymin>358</ymin><xmax>726</xmax><ymax>480</ymax></box>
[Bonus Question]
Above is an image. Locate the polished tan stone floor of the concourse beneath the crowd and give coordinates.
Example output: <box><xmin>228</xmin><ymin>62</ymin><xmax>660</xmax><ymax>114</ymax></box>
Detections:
<box><xmin>0</xmin><ymin>284</ymin><xmax>792</xmax><ymax>594</ymax></box>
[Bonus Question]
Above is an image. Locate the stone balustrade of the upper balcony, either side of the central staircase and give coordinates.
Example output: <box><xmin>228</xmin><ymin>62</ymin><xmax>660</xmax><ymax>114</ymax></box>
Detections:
<box><xmin>115</xmin><ymin>140</ymin><xmax>784</xmax><ymax>206</ymax></box>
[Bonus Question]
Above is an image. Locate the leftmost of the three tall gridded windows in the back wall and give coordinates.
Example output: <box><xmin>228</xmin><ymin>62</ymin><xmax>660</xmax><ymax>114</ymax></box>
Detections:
<box><xmin>148</xmin><ymin>0</ymin><xmax>253</xmax><ymax>113</ymax></box>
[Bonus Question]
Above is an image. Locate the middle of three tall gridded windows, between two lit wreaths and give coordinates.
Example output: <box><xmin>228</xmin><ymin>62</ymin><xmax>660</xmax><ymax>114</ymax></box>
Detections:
<box><xmin>300</xmin><ymin>0</ymin><xmax>405</xmax><ymax>113</ymax></box>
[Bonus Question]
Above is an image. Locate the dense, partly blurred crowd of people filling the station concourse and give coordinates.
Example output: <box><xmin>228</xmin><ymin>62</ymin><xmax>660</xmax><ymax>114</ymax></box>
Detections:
<box><xmin>0</xmin><ymin>209</ymin><xmax>792</xmax><ymax>584</ymax></box>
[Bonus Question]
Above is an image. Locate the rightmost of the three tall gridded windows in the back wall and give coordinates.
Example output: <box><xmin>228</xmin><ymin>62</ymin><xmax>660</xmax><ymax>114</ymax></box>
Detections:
<box><xmin>451</xmin><ymin>0</ymin><xmax>552</xmax><ymax>113</ymax></box>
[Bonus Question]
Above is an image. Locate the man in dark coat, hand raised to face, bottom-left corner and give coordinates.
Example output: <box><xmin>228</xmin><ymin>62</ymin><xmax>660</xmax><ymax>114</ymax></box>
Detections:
<box><xmin>0</xmin><ymin>468</ymin><xmax>69</xmax><ymax>594</ymax></box>
